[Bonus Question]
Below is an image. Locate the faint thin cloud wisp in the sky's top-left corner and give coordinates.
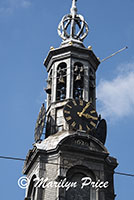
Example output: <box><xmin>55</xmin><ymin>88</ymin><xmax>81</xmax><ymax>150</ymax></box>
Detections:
<box><xmin>0</xmin><ymin>0</ymin><xmax>31</xmax><ymax>14</ymax></box>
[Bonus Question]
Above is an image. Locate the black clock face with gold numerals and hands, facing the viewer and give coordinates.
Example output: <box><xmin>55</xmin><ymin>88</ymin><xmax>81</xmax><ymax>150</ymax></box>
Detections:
<box><xmin>63</xmin><ymin>99</ymin><xmax>98</xmax><ymax>132</ymax></box>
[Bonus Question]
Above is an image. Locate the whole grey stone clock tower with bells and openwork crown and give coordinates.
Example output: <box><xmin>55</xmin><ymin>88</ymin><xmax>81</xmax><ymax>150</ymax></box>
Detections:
<box><xmin>23</xmin><ymin>0</ymin><xmax>117</xmax><ymax>200</ymax></box>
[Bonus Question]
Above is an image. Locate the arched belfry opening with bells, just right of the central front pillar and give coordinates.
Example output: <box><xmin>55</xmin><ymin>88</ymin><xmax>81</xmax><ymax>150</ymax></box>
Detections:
<box><xmin>73</xmin><ymin>62</ymin><xmax>84</xmax><ymax>99</ymax></box>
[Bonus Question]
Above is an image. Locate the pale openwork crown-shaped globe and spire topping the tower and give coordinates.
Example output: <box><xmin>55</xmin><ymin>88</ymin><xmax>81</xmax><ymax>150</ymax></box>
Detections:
<box><xmin>58</xmin><ymin>0</ymin><xmax>89</xmax><ymax>44</ymax></box>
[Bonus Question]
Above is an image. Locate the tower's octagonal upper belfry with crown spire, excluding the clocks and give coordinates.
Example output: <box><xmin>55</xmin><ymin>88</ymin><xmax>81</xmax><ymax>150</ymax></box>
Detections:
<box><xmin>44</xmin><ymin>1</ymin><xmax>100</xmax><ymax>137</ymax></box>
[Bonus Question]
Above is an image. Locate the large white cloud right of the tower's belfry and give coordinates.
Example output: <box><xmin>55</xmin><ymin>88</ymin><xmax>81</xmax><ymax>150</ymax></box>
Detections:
<box><xmin>97</xmin><ymin>63</ymin><xmax>134</xmax><ymax>119</ymax></box>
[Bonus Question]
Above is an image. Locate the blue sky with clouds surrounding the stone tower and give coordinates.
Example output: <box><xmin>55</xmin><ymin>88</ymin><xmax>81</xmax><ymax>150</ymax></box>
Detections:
<box><xmin>0</xmin><ymin>0</ymin><xmax>134</xmax><ymax>200</ymax></box>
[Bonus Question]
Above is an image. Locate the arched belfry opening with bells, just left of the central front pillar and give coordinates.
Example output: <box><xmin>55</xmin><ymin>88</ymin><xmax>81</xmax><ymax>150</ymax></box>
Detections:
<box><xmin>56</xmin><ymin>62</ymin><xmax>67</xmax><ymax>100</ymax></box>
